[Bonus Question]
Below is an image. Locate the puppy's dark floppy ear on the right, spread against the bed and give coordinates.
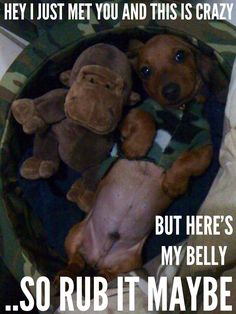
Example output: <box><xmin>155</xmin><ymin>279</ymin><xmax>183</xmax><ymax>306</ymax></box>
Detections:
<box><xmin>194</xmin><ymin>49</ymin><xmax>229</xmax><ymax>101</ymax></box>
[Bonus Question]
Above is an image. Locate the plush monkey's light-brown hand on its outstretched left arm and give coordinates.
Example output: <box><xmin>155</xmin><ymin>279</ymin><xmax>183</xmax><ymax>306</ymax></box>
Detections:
<box><xmin>11</xmin><ymin>98</ymin><xmax>46</xmax><ymax>134</ymax></box>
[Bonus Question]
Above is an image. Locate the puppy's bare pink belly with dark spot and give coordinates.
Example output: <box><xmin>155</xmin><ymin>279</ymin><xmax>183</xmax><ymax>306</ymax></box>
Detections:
<box><xmin>80</xmin><ymin>160</ymin><xmax>171</xmax><ymax>268</ymax></box>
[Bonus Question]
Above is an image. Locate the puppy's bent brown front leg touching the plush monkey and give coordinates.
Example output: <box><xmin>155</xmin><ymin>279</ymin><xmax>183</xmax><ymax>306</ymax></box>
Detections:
<box><xmin>120</xmin><ymin>109</ymin><xmax>156</xmax><ymax>159</ymax></box>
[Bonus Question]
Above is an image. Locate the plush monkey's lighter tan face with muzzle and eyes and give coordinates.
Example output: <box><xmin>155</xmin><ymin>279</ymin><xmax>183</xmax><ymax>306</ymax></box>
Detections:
<box><xmin>65</xmin><ymin>65</ymin><xmax>125</xmax><ymax>134</ymax></box>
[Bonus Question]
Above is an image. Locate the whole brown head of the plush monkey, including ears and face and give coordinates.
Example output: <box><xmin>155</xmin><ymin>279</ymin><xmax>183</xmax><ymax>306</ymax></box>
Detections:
<box><xmin>61</xmin><ymin>44</ymin><xmax>136</xmax><ymax>134</ymax></box>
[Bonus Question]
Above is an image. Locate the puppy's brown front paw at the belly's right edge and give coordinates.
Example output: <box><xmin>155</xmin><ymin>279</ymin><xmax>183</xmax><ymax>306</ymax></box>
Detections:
<box><xmin>162</xmin><ymin>170</ymin><xmax>189</xmax><ymax>198</ymax></box>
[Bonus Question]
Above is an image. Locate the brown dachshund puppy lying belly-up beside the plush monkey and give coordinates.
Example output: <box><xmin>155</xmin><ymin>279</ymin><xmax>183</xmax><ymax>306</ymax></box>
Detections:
<box><xmin>56</xmin><ymin>35</ymin><xmax>218</xmax><ymax>280</ymax></box>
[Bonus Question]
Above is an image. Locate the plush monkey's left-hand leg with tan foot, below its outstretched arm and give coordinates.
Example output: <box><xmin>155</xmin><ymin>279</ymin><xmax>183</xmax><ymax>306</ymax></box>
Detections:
<box><xmin>20</xmin><ymin>130</ymin><xmax>60</xmax><ymax>180</ymax></box>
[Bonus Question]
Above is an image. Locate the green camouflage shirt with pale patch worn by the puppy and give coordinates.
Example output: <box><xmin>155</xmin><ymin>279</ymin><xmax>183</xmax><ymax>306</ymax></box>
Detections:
<box><xmin>136</xmin><ymin>99</ymin><xmax>211</xmax><ymax>170</ymax></box>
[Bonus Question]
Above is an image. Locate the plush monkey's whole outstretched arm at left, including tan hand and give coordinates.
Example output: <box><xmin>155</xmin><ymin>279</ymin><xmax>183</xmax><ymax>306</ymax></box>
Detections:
<box><xmin>11</xmin><ymin>88</ymin><xmax>67</xmax><ymax>134</ymax></box>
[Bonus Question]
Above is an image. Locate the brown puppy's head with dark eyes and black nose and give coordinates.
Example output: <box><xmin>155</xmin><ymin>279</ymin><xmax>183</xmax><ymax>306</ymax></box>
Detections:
<box><xmin>129</xmin><ymin>35</ymin><xmax>227</xmax><ymax>106</ymax></box>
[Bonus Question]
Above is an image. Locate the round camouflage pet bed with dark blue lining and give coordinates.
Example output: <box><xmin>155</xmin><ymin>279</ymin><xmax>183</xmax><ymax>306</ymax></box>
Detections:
<box><xmin>0</xmin><ymin>1</ymin><xmax>236</xmax><ymax>304</ymax></box>
